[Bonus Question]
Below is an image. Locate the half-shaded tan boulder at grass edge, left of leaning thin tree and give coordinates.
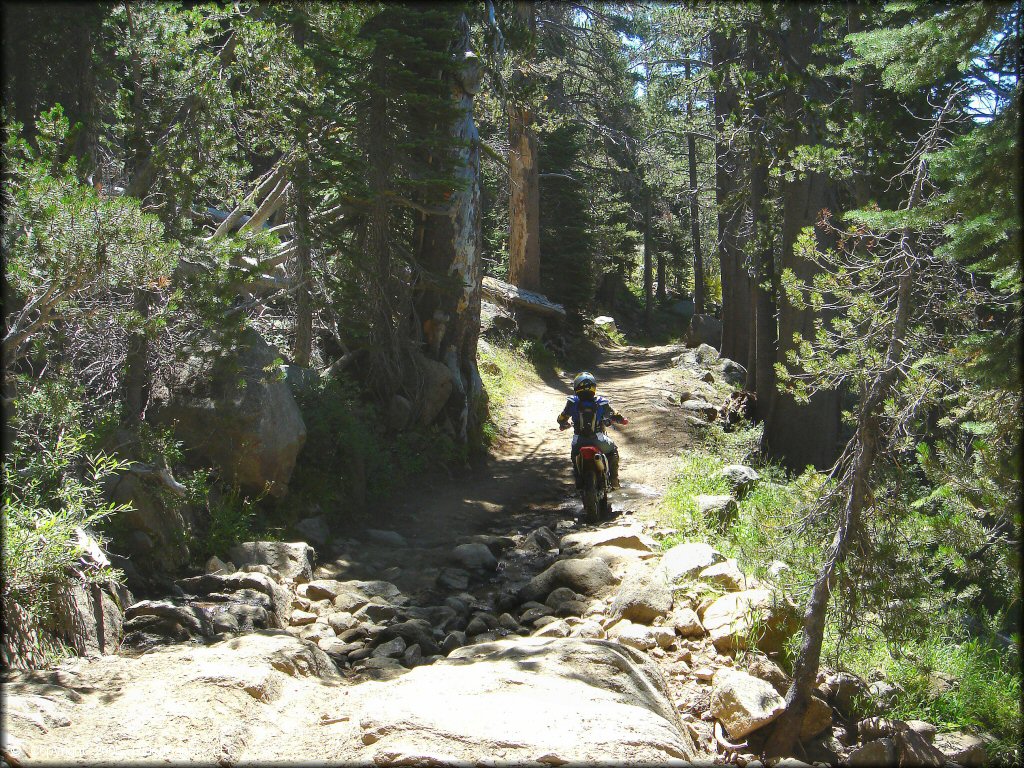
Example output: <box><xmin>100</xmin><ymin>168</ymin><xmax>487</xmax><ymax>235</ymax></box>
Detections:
<box><xmin>700</xmin><ymin>589</ymin><xmax>800</xmax><ymax>653</ymax></box>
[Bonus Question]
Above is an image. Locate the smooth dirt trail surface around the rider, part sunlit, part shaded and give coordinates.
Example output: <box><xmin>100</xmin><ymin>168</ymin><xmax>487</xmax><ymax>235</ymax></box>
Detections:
<box><xmin>353</xmin><ymin>345</ymin><xmax>690</xmax><ymax>546</ymax></box>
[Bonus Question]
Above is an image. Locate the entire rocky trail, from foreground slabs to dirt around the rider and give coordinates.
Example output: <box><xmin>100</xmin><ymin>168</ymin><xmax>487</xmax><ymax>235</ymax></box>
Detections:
<box><xmin>3</xmin><ymin>348</ymin><xmax>983</xmax><ymax>766</ymax></box>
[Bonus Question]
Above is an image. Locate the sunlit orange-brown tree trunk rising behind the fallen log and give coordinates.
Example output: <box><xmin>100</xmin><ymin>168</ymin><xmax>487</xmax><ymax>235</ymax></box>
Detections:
<box><xmin>508</xmin><ymin>2</ymin><xmax>541</xmax><ymax>291</ymax></box>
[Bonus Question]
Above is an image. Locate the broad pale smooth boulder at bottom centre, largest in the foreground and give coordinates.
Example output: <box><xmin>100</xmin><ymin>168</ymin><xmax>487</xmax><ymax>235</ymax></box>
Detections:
<box><xmin>359</xmin><ymin>638</ymin><xmax>697</xmax><ymax>765</ymax></box>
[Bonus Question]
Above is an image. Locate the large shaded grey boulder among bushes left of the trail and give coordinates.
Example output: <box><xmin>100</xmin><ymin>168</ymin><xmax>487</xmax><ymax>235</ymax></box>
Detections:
<box><xmin>153</xmin><ymin>329</ymin><xmax>306</xmax><ymax>497</ymax></box>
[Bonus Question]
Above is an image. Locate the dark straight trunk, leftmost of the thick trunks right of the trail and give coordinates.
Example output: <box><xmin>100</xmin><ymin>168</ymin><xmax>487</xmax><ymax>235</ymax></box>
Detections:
<box><xmin>711</xmin><ymin>32</ymin><xmax>751</xmax><ymax>360</ymax></box>
